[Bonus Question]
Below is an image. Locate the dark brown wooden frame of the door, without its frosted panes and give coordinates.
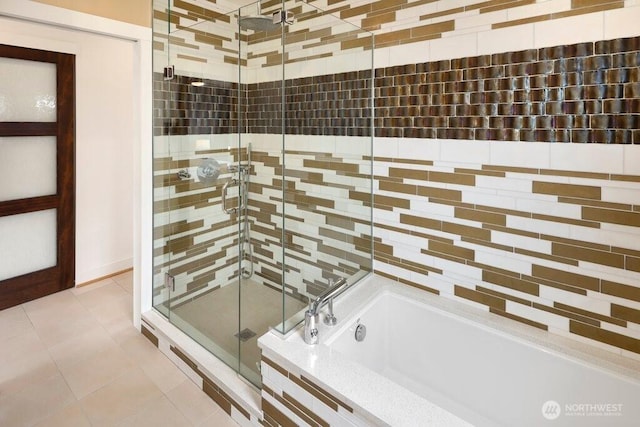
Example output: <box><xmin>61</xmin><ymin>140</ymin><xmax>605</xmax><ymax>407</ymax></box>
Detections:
<box><xmin>0</xmin><ymin>44</ymin><xmax>76</xmax><ymax>309</ymax></box>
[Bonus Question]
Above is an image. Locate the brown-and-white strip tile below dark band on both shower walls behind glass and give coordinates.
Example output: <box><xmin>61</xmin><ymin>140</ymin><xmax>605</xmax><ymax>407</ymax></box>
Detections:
<box><xmin>154</xmin><ymin>134</ymin><xmax>371</xmax><ymax>304</ymax></box>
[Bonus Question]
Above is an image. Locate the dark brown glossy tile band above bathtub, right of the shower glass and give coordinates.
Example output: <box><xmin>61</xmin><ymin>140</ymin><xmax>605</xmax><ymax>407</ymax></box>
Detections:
<box><xmin>375</xmin><ymin>37</ymin><xmax>640</xmax><ymax>144</ymax></box>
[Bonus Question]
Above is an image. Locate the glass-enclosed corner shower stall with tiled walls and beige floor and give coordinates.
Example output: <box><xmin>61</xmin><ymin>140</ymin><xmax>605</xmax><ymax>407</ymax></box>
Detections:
<box><xmin>153</xmin><ymin>0</ymin><xmax>374</xmax><ymax>387</ymax></box>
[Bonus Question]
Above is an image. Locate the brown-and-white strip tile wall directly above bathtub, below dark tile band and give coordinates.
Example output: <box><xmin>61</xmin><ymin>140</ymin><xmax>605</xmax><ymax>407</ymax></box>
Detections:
<box><xmin>374</xmin><ymin>138</ymin><xmax>640</xmax><ymax>358</ymax></box>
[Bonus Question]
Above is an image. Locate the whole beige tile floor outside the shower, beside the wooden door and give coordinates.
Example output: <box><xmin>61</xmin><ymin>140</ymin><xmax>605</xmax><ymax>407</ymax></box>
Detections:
<box><xmin>0</xmin><ymin>273</ymin><xmax>237</xmax><ymax>427</ymax></box>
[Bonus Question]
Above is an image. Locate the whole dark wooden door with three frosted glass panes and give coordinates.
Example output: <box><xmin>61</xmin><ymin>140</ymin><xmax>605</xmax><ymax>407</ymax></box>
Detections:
<box><xmin>0</xmin><ymin>45</ymin><xmax>75</xmax><ymax>309</ymax></box>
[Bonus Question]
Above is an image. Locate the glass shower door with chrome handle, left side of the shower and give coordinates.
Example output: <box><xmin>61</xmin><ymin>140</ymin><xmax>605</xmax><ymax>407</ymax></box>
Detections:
<box><xmin>154</xmin><ymin>13</ymin><xmax>242</xmax><ymax>382</ymax></box>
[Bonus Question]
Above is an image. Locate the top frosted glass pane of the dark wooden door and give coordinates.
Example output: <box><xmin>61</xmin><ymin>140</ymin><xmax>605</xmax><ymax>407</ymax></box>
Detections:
<box><xmin>0</xmin><ymin>58</ymin><xmax>56</xmax><ymax>122</ymax></box>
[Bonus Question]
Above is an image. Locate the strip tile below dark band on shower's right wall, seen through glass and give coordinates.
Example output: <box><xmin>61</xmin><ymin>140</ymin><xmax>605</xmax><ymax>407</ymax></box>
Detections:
<box><xmin>247</xmin><ymin>134</ymin><xmax>372</xmax><ymax>301</ymax></box>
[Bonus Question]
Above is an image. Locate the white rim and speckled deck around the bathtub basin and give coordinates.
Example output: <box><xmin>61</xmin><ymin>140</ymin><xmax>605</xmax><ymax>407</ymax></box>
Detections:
<box><xmin>258</xmin><ymin>274</ymin><xmax>640</xmax><ymax>426</ymax></box>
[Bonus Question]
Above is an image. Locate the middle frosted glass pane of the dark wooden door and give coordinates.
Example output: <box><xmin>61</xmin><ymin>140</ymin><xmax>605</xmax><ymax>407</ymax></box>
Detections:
<box><xmin>0</xmin><ymin>136</ymin><xmax>56</xmax><ymax>201</ymax></box>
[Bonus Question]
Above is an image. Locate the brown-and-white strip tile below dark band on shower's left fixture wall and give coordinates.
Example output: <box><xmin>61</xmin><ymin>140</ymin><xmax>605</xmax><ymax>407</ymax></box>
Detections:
<box><xmin>153</xmin><ymin>142</ymin><xmax>248</xmax><ymax>306</ymax></box>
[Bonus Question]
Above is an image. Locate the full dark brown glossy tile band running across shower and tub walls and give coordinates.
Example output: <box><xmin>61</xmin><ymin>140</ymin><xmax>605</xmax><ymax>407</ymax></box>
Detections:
<box><xmin>154</xmin><ymin>36</ymin><xmax>640</xmax><ymax>144</ymax></box>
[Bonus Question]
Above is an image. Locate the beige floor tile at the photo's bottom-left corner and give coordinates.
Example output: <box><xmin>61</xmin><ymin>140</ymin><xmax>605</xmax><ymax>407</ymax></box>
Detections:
<box><xmin>0</xmin><ymin>374</ymin><xmax>75</xmax><ymax>426</ymax></box>
